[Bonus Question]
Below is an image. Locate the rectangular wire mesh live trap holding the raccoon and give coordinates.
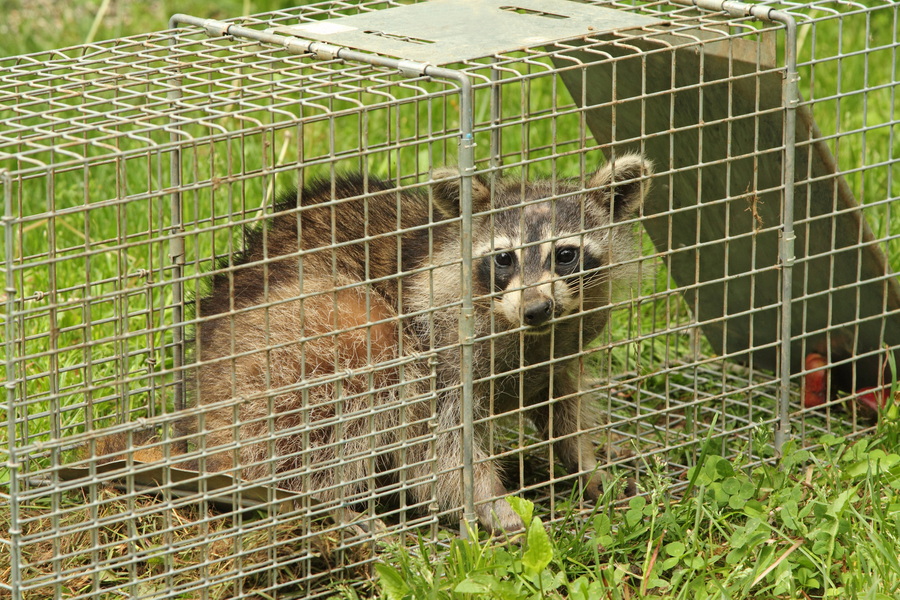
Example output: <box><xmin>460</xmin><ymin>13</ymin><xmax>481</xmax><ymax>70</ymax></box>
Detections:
<box><xmin>0</xmin><ymin>0</ymin><xmax>900</xmax><ymax>598</ymax></box>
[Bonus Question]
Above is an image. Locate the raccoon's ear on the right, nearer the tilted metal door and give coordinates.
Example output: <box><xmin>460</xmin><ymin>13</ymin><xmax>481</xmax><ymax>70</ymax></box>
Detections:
<box><xmin>589</xmin><ymin>154</ymin><xmax>653</xmax><ymax>221</ymax></box>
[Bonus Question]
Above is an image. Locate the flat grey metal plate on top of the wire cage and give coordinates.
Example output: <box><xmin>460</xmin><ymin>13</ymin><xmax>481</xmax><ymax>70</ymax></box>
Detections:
<box><xmin>272</xmin><ymin>0</ymin><xmax>661</xmax><ymax>65</ymax></box>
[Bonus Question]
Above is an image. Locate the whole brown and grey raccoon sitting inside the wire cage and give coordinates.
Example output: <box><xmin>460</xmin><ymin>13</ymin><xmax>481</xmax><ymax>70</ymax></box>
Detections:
<box><xmin>112</xmin><ymin>155</ymin><xmax>652</xmax><ymax>531</ymax></box>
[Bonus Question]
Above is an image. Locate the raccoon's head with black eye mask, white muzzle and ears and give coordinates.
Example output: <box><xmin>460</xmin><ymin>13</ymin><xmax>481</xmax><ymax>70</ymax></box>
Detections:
<box><xmin>435</xmin><ymin>155</ymin><xmax>652</xmax><ymax>335</ymax></box>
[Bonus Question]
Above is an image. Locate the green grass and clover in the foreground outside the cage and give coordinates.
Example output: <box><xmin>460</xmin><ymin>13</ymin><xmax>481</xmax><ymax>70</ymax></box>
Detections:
<box><xmin>364</xmin><ymin>406</ymin><xmax>900</xmax><ymax>600</ymax></box>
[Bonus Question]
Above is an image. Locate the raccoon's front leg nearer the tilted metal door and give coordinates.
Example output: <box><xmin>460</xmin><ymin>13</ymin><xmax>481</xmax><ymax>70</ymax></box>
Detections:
<box><xmin>533</xmin><ymin>370</ymin><xmax>603</xmax><ymax>500</ymax></box>
